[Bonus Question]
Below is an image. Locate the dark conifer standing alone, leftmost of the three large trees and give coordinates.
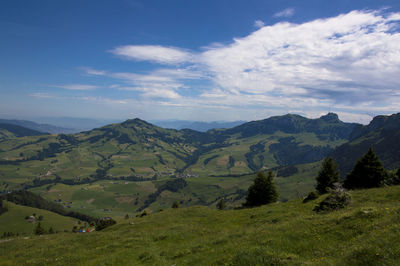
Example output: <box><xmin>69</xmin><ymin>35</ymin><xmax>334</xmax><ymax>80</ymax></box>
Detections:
<box><xmin>243</xmin><ymin>172</ymin><xmax>279</xmax><ymax>207</ymax></box>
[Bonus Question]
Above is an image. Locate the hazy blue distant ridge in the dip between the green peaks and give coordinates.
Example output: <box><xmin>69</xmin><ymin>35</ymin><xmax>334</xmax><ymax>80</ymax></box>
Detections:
<box><xmin>150</xmin><ymin>120</ymin><xmax>246</xmax><ymax>132</ymax></box>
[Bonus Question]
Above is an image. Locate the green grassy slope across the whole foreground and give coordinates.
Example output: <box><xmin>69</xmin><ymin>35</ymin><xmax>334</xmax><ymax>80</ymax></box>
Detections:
<box><xmin>0</xmin><ymin>186</ymin><xmax>400</xmax><ymax>265</ymax></box>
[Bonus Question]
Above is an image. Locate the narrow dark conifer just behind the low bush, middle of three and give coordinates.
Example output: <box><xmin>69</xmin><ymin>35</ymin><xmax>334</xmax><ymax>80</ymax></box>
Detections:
<box><xmin>316</xmin><ymin>157</ymin><xmax>340</xmax><ymax>194</ymax></box>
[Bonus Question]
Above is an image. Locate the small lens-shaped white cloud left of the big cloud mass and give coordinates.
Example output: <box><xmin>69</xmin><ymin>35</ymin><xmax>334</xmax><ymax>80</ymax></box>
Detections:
<box><xmin>111</xmin><ymin>45</ymin><xmax>192</xmax><ymax>64</ymax></box>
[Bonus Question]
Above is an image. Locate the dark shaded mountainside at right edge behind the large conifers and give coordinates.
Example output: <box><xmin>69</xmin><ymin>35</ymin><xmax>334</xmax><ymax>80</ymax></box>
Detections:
<box><xmin>331</xmin><ymin>113</ymin><xmax>400</xmax><ymax>176</ymax></box>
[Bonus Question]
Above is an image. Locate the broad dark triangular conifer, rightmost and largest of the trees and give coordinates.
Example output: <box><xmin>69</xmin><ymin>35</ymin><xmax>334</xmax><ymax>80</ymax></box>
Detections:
<box><xmin>344</xmin><ymin>148</ymin><xmax>387</xmax><ymax>189</ymax></box>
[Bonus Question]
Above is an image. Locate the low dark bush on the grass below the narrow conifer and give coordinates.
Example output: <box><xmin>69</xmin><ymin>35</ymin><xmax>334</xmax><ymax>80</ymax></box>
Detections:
<box><xmin>314</xmin><ymin>185</ymin><xmax>351</xmax><ymax>212</ymax></box>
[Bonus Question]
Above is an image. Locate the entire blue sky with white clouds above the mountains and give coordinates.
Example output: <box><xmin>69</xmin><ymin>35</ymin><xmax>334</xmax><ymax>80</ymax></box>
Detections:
<box><xmin>0</xmin><ymin>0</ymin><xmax>400</xmax><ymax>124</ymax></box>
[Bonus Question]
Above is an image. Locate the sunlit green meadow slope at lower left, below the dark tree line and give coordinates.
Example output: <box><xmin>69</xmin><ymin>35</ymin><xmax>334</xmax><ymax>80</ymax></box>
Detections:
<box><xmin>0</xmin><ymin>201</ymin><xmax>78</xmax><ymax>234</ymax></box>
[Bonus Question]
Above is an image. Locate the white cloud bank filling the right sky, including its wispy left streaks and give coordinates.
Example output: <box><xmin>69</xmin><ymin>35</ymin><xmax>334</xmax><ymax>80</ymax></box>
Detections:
<box><xmin>80</xmin><ymin>9</ymin><xmax>400</xmax><ymax>122</ymax></box>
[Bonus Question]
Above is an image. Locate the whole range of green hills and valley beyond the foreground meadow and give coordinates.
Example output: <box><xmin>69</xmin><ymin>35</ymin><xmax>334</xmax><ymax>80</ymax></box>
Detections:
<box><xmin>0</xmin><ymin>113</ymin><xmax>400</xmax><ymax>215</ymax></box>
